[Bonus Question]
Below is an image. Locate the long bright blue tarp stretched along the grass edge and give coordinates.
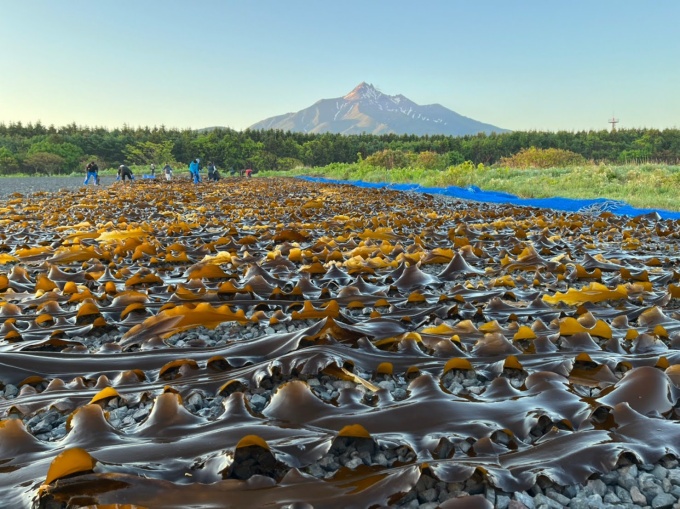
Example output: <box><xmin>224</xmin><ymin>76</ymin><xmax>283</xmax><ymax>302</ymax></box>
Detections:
<box><xmin>298</xmin><ymin>177</ymin><xmax>680</xmax><ymax>219</ymax></box>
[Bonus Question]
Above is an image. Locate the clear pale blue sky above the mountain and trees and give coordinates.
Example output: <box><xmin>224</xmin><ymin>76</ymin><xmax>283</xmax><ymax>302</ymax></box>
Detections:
<box><xmin>0</xmin><ymin>0</ymin><xmax>680</xmax><ymax>131</ymax></box>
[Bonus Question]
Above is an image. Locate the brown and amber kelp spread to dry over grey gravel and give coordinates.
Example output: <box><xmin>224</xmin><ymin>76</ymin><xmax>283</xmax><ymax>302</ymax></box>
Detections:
<box><xmin>0</xmin><ymin>178</ymin><xmax>680</xmax><ymax>508</ymax></box>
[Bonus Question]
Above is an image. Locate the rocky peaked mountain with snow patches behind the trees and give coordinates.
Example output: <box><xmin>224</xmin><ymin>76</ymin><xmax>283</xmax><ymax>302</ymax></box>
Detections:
<box><xmin>249</xmin><ymin>83</ymin><xmax>508</xmax><ymax>136</ymax></box>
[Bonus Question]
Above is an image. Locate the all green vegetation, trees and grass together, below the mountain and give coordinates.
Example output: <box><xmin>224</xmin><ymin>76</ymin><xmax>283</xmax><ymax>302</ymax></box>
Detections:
<box><xmin>0</xmin><ymin>123</ymin><xmax>680</xmax><ymax>210</ymax></box>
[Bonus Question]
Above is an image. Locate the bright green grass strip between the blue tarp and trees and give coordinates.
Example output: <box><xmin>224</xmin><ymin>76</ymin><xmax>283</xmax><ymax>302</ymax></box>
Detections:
<box><xmin>258</xmin><ymin>163</ymin><xmax>680</xmax><ymax>210</ymax></box>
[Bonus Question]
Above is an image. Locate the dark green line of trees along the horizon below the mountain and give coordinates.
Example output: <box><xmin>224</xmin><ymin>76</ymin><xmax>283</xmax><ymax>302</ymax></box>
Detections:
<box><xmin>0</xmin><ymin>122</ymin><xmax>680</xmax><ymax>175</ymax></box>
